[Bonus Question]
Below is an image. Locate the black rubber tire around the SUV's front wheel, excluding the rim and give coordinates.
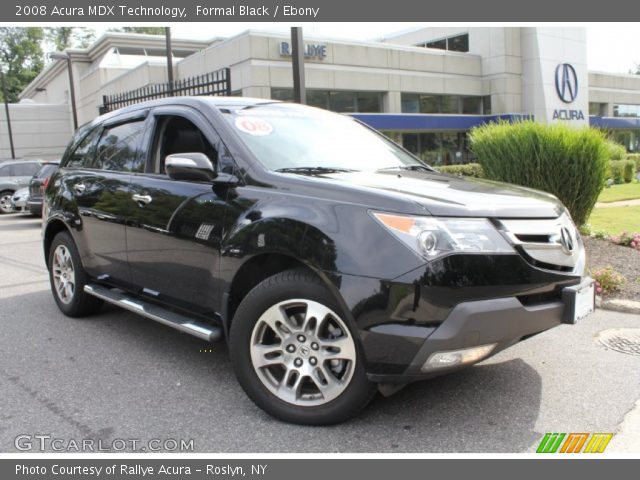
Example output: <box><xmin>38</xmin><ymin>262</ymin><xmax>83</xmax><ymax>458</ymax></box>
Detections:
<box><xmin>229</xmin><ymin>271</ymin><xmax>375</xmax><ymax>425</ymax></box>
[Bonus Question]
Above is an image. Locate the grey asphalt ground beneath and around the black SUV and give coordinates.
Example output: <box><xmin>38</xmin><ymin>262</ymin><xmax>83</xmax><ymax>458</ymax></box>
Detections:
<box><xmin>0</xmin><ymin>215</ymin><xmax>640</xmax><ymax>453</ymax></box>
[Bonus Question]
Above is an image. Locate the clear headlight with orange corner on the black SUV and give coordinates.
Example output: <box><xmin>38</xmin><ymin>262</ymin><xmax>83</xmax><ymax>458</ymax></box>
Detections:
<box><xmin>371</xmin><ymin>212</ymin><xmax>514</xmax><ymax>260</ymax></box>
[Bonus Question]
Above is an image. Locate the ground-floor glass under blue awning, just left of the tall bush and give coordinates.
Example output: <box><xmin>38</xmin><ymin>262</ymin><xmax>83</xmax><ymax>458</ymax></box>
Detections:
<box><xmin>402</xmin><ymin>132</ymin><xmax>475</xmax><ymax>166</ymax></box>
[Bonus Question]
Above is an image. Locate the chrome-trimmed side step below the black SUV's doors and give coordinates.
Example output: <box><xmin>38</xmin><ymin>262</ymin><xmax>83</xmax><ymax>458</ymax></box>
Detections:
<box><xmin>84</xmin><ymin>284</ymin><xmax>222</xmax><ymax>342</ymax></box>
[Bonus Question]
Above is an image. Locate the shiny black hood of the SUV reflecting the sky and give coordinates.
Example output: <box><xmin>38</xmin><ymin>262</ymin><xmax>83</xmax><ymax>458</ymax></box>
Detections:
<box><xmin>290</xmin><ymin>170</ymin><xmax>565</xmax><ymax>218</ymax></box>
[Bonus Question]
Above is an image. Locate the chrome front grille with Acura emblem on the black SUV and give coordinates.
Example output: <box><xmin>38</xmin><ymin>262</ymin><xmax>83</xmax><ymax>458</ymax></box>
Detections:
<box><xmin>499</xmin><ymin>214</ymin><xmax>584</xmax><ymax>273</ymax></box>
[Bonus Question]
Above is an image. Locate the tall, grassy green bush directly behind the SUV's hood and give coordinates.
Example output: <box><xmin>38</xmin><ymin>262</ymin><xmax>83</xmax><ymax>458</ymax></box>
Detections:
<box><xmin>470</xmin><ymin>121</ymin><xmax>609</xmax><ymax>225</ymax></box>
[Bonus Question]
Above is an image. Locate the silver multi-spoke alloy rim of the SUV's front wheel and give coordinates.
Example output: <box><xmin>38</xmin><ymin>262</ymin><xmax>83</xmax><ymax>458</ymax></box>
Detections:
<box><xmin>250</xmin><ymin>299</ymin><xmax>356</xmax><ymax>406</ymax></box>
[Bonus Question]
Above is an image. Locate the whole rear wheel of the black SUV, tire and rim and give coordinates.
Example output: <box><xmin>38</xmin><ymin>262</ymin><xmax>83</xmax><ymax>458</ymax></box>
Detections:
<box><xmin>47</xmin><ymin>232</ymin><xmax>103</xmax><ymax>317</ymax></box>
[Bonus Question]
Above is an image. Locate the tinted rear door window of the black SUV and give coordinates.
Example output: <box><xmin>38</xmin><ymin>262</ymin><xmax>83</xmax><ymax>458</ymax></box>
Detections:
<box><xmin>94</xmin><ymin>121</ymin><xmax>144</xmax><ymax>172</ymax></box>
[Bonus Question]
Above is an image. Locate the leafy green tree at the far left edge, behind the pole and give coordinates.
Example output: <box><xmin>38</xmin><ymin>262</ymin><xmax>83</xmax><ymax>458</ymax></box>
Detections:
<box><xmin>0</xmin><ymin>27</ymin><xmax>44</xmax><ymax>102</ymax></box>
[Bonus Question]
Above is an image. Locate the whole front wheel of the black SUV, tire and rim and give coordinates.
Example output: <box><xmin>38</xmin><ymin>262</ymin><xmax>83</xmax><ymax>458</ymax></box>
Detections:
<box><xmin>229</xmin><ymin>270</ymin><xmax>376</xmax><ymax>425</ymax></box>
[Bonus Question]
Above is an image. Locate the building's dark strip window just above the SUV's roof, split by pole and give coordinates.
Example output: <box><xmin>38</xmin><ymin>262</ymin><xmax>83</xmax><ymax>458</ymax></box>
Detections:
<box><xmin>271</xmin><ymin>88</ymin><xmax>382</xmax><ymax>113</ymax></box>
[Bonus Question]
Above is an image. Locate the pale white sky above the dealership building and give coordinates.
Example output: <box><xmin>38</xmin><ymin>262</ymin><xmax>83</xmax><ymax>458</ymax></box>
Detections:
<box><xmin>91</xmin><ymin>22</ymin><xmax>640</xmax><ymax>73</ymax></box>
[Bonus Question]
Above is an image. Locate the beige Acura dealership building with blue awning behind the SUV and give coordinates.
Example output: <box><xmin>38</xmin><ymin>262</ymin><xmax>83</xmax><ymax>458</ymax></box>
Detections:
<box><xmin>8</xmin><ymin>27</ymin><xmax>640</xmax><ymax>164</ymax></box>
